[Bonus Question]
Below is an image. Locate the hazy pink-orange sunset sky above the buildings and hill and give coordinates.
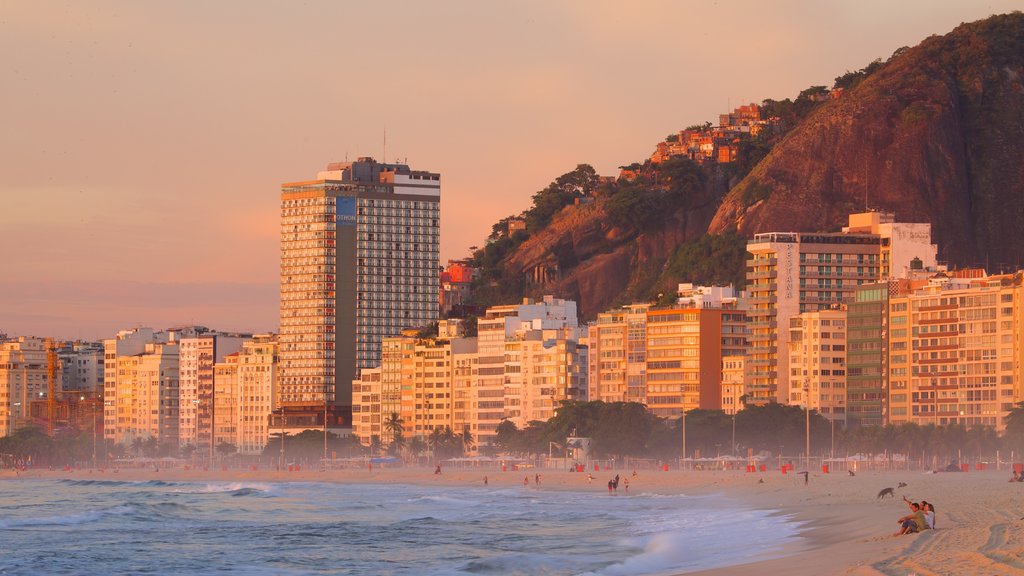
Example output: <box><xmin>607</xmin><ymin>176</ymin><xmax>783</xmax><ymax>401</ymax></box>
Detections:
<box><xmin>0</xmin><ymin>0</ymin><xmax>1024</xmax><ymax>339</ymax></box>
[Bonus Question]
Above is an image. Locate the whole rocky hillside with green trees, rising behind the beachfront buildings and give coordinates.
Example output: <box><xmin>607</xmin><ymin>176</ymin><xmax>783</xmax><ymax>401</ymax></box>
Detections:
<box><xmin>474</xmin><ymin>13</ymin><xmax>1024</xmax><ymax>319</ymax></box>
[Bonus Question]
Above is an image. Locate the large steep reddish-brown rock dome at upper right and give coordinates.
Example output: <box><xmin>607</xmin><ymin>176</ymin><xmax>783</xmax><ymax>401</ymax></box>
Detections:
<box><xmin>710</xmin><ymin>13</ymin><xmax>1024</xmax><ymax>268</ymax></box>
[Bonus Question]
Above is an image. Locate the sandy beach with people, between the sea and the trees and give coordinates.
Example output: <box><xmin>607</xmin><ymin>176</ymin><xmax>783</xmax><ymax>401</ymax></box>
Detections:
<box><xmin>0</xmin><ymin>461</ymin><xmax>1024</xmax><ymax>576</ymax></box>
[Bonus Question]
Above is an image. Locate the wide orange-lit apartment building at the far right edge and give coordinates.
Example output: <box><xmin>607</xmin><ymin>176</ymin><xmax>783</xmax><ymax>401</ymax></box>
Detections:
<box><xmin>888</xmin><ymin>273</ymin><xmax>1024</xmax><ymax>431</ymax></box>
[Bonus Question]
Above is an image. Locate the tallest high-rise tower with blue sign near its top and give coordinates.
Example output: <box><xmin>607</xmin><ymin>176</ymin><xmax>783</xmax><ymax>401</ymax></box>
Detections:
<box><xmin>276</xmin><ymin>158</ymin><xmax>440</xmax><ymax>427</ymax></box>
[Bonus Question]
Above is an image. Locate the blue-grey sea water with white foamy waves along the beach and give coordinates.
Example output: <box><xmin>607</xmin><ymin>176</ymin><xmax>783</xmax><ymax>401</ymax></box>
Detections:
<box><xmin>0</xmin><ymin>480</ymin><xmax>799</xmax><ymax>576</ymax></box>
